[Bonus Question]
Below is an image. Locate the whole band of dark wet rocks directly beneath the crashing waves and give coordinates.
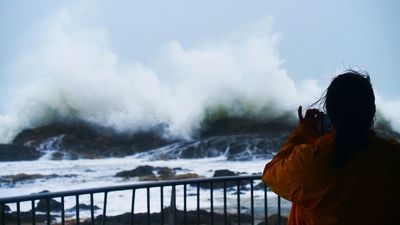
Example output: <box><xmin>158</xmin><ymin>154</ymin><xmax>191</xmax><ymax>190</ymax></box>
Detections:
<box><xmin>0</xmin><ymin>119</ymin><xmax>291</xmax><ymax>161</ymax></box>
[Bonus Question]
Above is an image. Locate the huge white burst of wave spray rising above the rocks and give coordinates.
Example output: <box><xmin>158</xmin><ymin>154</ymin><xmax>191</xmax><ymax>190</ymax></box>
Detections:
<box><xmin>0</xmin><ymin>10</ymin><xmax>316</xmax><ymax>142</ymax></box>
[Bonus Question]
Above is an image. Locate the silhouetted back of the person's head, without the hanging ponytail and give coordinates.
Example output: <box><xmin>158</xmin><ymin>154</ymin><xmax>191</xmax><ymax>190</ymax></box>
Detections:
<box><xmin>325</xmin><ymin>71</ymin><xmax>376</xmax><ymax>130</ymax></box>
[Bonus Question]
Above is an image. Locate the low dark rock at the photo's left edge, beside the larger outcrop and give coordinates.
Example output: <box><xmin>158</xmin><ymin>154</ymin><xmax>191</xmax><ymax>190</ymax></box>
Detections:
<box><xmin>0</xmin><ymin>144</ymin><xmax>42</xmax><ymax>161</ymax></box>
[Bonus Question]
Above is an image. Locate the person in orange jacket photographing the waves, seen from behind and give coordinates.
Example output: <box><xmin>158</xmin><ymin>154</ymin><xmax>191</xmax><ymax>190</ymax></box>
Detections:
<box><xmin>262</xmin><ymin>71</ymin><xmax>400</xmax><ymax>225</ymax></box>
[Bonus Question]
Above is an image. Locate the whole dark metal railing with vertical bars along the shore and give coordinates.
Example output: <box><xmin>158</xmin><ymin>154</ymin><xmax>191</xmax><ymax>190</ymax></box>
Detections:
<box><xmin>0</xmin><ymin>175</ymin><xmax>281</xmax><ymax>225</ymax></box>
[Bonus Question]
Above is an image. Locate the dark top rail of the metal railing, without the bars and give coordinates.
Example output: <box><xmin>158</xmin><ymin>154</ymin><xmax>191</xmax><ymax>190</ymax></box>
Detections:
<box><xmin>0</xmin><ymin>175</ymin><xmax>261</xmax><ymax>204</ymax></box>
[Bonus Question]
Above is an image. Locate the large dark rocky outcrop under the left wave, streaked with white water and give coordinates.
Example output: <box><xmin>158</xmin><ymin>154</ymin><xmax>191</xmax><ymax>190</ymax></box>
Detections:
<box><xmin>13</xmin><ymin>122</ymin><xmax>172</xmax><ymax>159</ymax></box>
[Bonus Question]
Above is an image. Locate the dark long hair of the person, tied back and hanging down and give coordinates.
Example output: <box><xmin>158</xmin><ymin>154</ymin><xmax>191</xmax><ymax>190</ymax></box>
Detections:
<box><xmin>324</xmin><ymin>70</ymin><xmax>376</xmax><ymax>168</ymax></box>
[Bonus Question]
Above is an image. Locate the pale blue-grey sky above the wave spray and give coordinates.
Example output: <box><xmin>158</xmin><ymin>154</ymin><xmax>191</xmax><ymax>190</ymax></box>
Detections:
<box><xmin>0</xmin><ymin>0</ymin><xmax>400</xmax><ymax>101</ymax></box>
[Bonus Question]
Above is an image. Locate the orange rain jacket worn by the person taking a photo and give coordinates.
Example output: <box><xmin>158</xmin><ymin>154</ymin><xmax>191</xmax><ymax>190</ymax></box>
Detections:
<box><xmin>262</xmin><ymin>123</ymin><xmax>400</xmax><ymax>225</ymax></box>
